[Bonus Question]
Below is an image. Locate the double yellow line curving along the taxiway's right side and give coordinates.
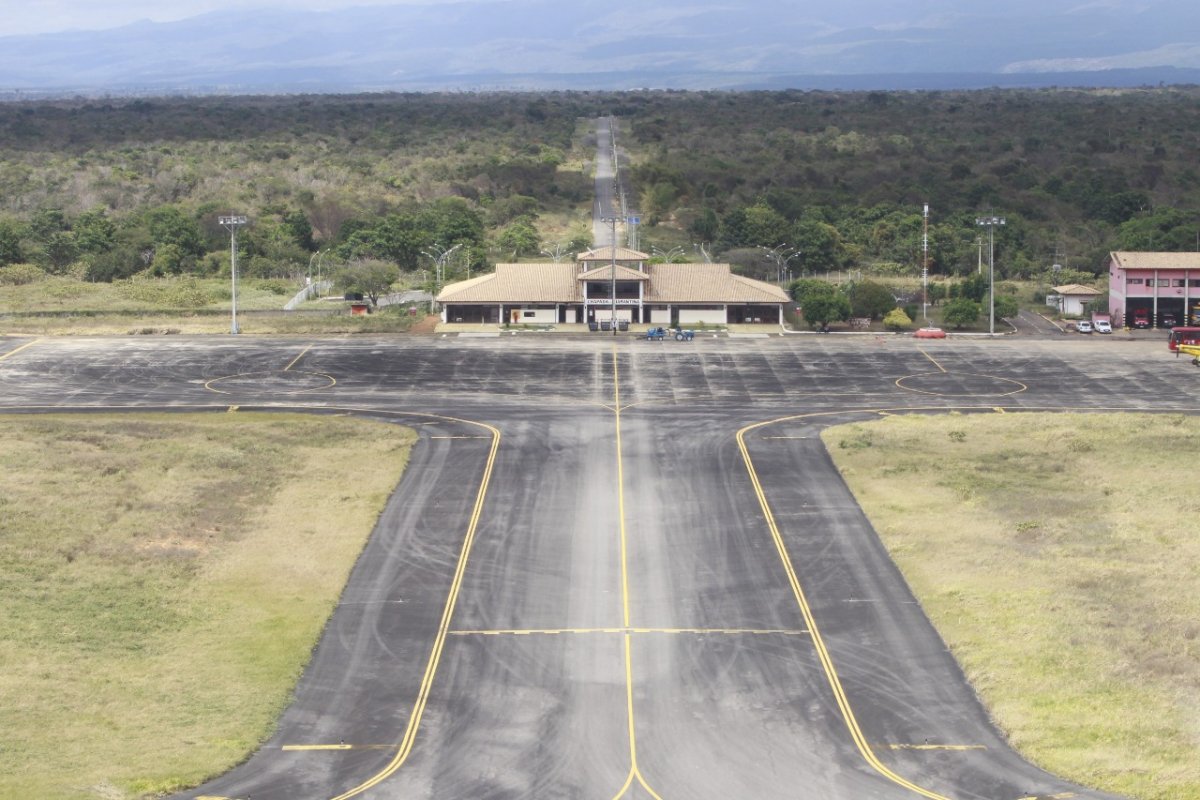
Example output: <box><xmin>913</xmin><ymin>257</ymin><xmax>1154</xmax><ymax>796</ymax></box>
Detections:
<box><xmin>737</xmin><ymin>417</ymin><xmax>949</xmax><ymax>800</ymax></box>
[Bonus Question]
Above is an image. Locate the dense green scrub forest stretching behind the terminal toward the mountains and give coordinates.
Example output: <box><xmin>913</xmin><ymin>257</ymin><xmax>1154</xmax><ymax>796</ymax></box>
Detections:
<box><xmin>0</xmin><ymin>88</ymin><xmax>1200</xmax><ymax>289</ymax></box>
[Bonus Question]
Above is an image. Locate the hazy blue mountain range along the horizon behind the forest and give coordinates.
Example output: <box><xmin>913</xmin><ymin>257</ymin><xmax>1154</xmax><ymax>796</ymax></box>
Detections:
<box><xmin>0</xmin><ymin>0</ymin><xmax>1200</xmax><ymax>97</ymax></box>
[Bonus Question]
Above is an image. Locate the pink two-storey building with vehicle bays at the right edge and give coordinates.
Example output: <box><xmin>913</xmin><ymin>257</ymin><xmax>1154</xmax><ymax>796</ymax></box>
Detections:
<box><xmin>1109</xmin><ymin>252</ymin><xmax>1200</xmax><ymax>327</ymax></box>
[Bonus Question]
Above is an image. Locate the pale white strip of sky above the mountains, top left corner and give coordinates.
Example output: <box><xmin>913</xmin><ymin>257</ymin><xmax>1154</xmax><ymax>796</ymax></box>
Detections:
<box><xmin>0</xmin><ymin>0</ymin><xmax>451</xmax><ymax>36</ymax></box>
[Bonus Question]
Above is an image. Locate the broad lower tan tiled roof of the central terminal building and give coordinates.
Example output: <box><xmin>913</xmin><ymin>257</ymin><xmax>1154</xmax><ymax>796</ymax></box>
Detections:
<box><xmin>438</xmin><ymin>263</ymin><xmax>790</xmax><ymax>303</ymax></box>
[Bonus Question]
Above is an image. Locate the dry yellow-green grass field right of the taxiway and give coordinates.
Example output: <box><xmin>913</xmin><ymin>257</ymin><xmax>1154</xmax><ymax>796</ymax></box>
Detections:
<box><xmin>824</xmin><ymin>414</ymin><xmax>1200</xmax><ymax>800</ymax></box>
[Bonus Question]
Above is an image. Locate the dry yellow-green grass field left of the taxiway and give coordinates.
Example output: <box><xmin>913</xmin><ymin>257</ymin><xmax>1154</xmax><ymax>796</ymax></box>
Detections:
<box><xmin>0</xmin><ymin>414</ymin><xmax>415</xmax><ymax>800</ymax></box>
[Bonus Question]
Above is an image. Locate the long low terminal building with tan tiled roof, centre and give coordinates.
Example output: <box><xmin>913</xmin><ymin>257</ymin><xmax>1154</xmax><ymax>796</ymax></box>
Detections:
<box><xmin>437</xmin><ymin>247</ymin><xmax>790</xmax><ymax>330</ymax></box>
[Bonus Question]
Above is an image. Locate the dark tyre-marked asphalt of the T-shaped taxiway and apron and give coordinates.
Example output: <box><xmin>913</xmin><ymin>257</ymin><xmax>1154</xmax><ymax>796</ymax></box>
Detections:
<box><xmin>0</xmin><ymin>335</ymin><xmax>1185</xmax><ymax>800</ymax></box>
